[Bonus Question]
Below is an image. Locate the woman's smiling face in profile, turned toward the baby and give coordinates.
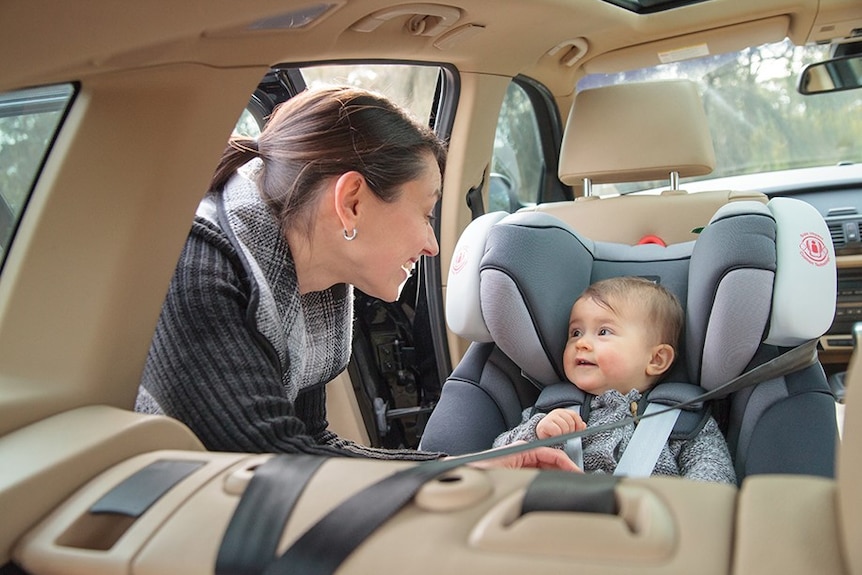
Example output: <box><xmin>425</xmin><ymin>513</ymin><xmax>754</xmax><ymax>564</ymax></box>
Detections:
<box><xmin>351</xmin><ymin>153</ymin><xmax>442</xmax><ymax>301</ymax></box>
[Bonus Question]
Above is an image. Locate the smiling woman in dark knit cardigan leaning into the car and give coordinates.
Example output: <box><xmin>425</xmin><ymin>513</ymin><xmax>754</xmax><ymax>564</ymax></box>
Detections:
<box><xmin>136</xmin><ymin>87</ymin><xmax>570</xmax><ymax>468</ymax></box>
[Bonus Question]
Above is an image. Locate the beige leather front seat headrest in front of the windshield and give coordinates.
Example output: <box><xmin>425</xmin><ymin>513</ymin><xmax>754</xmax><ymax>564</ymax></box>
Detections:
<box><xmin>559</xmin><ymin>80</ymin><xmax>715</xmax><ymax>186</ymax></box>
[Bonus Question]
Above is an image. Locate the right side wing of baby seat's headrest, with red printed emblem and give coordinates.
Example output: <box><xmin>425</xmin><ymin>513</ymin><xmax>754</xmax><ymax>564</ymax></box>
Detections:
<box><xmin>686</xmin><ymin>198</ymin><xmax>836</xmax><ymax>389</ymax></box>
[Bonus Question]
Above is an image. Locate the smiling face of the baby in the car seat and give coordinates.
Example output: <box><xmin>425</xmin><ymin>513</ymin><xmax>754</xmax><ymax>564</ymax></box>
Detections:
<box><xmin>563</xmin><ymin>298</ymin><xmax>653</xmax><ymax>395</ymax></box>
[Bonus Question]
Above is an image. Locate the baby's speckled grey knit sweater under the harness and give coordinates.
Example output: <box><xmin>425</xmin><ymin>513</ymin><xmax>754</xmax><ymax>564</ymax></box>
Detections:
<box><xmin>494</xmin><ymin>390</ymin><xmax>736</xmax><ymax>484</ymax></box>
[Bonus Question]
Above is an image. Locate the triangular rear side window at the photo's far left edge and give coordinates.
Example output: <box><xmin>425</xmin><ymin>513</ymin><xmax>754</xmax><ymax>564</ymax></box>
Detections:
<box><xmin>0</xmin><ymin>84</ymin><xmax>75</xmax><ymax>263</ymax></box>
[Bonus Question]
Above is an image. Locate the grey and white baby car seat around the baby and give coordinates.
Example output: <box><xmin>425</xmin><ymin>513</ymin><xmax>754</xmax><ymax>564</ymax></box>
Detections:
<box><xmin>420</xmin><ymin>198</ymin><xmax>838</xmax><ymax>482</ymax></box>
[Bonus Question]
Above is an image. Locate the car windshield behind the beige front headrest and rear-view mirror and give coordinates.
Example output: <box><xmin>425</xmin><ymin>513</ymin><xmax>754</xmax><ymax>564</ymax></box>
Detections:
<box><xmin>578</xmin><ymin>40</ymin><xmax>862</xmax><ymax>195</ymax></box>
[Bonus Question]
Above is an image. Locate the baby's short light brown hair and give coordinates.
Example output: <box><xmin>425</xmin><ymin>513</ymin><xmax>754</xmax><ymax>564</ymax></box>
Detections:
<box><xmin>581</xmin><ymin>276</ymin><xmax>684</xmax><ymax>349</ymax></box>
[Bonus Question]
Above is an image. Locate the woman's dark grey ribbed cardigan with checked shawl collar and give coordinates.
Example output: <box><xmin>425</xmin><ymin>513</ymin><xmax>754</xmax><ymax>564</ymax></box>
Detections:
<box><xmin>136</xmin><ymin>161</ymin><xmax>440</xmax><ymax>460</ymax></box>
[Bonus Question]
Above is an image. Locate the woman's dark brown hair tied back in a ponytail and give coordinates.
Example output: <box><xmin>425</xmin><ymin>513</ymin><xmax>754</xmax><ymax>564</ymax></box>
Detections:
<box><xmin>210</xmin><ymin>87</ymin><xmax>446</xmax><ymax>232</ymax></box>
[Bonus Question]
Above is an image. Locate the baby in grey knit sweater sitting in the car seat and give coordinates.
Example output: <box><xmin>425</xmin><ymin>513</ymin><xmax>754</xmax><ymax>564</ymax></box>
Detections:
<box><xmin>494</xmin><ymin>277</ymin><xmax>736</xmax><ymax>484</ymax></box>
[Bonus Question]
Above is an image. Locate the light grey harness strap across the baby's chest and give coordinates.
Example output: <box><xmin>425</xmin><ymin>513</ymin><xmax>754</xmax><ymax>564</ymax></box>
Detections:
<box><xmin>614</xmin><ymin>403</ymin><xmax>680</xmax><ymax>477</ymax></box>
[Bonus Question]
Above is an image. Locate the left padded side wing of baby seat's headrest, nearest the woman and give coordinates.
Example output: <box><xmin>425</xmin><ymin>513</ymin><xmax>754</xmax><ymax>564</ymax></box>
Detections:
<box><xmin>446</xmin><ymin>212</ymin><xmax>592</xmax><ymax>382</ymax></box>
